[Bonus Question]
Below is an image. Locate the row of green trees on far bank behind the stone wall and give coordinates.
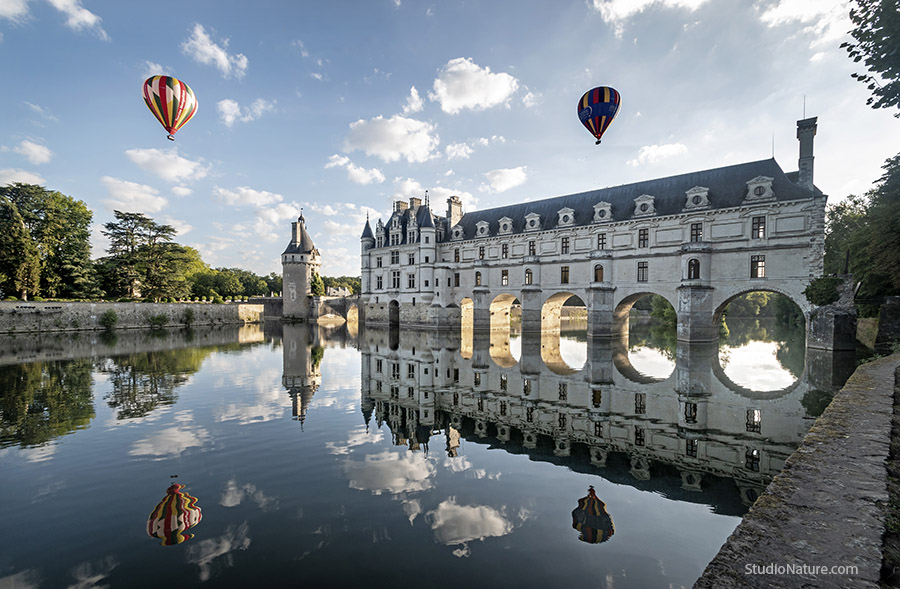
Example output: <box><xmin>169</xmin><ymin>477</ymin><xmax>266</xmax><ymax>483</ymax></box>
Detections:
<box><xmin>0</xmin><ymin>183</ymin><xmax>360</xmax><ymax>302</ymax></box>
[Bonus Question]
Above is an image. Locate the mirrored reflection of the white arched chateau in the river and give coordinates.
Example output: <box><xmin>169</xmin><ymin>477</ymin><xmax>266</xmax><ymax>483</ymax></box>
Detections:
<box><xmin>360</xmin><ymin>330</ymin><xmax>836</xmax><ymax>511</ymax></box>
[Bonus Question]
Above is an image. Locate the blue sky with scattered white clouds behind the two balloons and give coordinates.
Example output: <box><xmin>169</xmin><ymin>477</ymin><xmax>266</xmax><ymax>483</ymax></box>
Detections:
<box><xmin>0</xmin><ymin>0</ymin><xmax>900</xmax><ymax>276</ymax></box>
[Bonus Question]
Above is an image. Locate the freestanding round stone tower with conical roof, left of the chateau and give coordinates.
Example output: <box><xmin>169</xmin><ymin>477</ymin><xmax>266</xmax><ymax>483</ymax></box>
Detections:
<box><xmin>281</xmin><ymin>212</ymin><xmax>322</xmax><ymax>321</ymax></box>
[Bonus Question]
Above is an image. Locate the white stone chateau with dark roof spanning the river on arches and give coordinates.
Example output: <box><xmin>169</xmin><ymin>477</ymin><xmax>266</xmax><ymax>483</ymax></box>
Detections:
<box><xmin>362</xmin><ymin>117</ymin><xmax>827</xmax><ymax>341</ymax></box>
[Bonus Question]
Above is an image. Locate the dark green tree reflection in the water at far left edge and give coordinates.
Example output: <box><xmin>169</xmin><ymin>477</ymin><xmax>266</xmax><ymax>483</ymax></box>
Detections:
<box><xmin>0</xmin><ymin>360</ymin><xmax>94</xmax><ymax>447</ymax></box>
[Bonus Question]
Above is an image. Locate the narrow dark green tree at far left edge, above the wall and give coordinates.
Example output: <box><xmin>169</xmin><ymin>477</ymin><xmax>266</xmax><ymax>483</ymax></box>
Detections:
<box><xmin>0</xmin><ymin>195</ymin><xmax>41</xmax><ymax>300</ymax></box>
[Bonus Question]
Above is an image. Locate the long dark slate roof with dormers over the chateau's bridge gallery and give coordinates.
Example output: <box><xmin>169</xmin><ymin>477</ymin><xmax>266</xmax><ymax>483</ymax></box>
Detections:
<box><xmin>444</xmin><ymin>159</ymin><xmax>822</xmax><ymax>242</ymax></box>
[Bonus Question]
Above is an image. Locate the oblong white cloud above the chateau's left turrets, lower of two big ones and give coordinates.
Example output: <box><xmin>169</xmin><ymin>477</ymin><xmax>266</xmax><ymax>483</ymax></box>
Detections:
<box><xmin>344</xmin><ymin>115</ymin><xmax>440</xmax><ymax>163</ymax></box>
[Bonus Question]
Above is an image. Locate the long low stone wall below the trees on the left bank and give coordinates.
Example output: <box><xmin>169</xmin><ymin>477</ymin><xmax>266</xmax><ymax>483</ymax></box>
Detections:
<box><xmin>0</xmin><ymin>302</ymin><xmax>263</xmax><ymax>333</ymax></box>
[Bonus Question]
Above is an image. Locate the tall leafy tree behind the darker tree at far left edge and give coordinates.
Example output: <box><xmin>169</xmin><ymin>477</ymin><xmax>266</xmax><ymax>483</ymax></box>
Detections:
<box><xmin>0</xmin><ymin>183</ymin><xmax>98</xmax><ymax>298</ymax></box>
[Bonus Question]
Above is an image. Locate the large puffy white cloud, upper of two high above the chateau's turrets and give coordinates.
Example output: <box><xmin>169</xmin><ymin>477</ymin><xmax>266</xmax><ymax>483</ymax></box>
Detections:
<box><xmin>428</xmin><ymin>57</ymin><xmax>519</xmax><ymax>114</ymax></box>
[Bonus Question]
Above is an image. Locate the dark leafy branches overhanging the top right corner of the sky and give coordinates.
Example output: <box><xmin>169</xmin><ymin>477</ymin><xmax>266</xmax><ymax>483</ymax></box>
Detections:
<box><xmin>841</xmin><ymin>0</ymin><xmax>900</xmax><ymax>117</ymax></box>
